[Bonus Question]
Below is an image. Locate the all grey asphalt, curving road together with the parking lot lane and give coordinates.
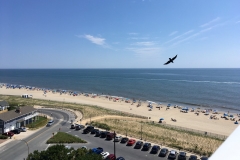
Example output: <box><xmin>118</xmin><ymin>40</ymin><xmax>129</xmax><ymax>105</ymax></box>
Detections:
<box><xmin>0</xmin><ymin>109</ymin><xmax>195</xmax><ymax>160</ymax></box>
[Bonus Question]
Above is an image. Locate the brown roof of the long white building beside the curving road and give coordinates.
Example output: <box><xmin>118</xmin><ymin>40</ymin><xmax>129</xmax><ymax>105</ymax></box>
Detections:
<box><xmin>0</xmin><ymin>106</ymin><xmax>37</xmax><ymax>122</ymax></box>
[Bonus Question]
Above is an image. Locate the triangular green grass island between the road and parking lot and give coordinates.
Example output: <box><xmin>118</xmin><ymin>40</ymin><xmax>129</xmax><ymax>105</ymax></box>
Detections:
<box><xmin>47</xmin><ymin>132</ymin><xmax>87</xmax><ymax>144</ymax></box>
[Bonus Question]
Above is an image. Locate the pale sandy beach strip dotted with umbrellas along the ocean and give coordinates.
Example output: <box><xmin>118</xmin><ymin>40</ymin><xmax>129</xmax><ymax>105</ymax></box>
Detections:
<box><xmin>0</xmin><ymin>87</ymin><xmax>239</xmax><ymax>136</ymax></box>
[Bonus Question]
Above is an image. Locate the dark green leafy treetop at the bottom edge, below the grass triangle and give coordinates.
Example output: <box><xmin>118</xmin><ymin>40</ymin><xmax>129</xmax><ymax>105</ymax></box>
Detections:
<box><xmin>27</xmin><ymin>144</ymin><xmax>102</xmax><ymax>160</ymax></box>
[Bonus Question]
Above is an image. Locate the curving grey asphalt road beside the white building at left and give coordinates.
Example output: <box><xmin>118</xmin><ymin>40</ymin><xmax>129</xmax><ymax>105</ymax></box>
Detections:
<box><xmin>0</xmin><ymin>110</ymin><xmax>71</xmax><ymax>160</ymax></box>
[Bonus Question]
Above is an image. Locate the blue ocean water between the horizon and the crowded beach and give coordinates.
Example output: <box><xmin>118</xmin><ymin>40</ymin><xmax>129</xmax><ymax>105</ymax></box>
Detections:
<box><xmin>0</xmin><ymin>69</ymin><xmax>240</xmax><ymax>111</ymax></box>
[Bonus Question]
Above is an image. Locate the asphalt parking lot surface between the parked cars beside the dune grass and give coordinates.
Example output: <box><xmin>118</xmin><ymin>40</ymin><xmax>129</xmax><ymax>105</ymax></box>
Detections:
<box><xmin>66</xmin><ymin>126</ymin><xmax>206</xmax><ymax>160</ymax></box>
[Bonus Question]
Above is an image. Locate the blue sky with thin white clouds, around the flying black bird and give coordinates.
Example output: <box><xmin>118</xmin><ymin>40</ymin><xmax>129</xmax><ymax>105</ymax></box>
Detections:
<box><xmin>0</xmin><ymin>0</ymin><xmax>240</xmax><ymax>69</ymax></box>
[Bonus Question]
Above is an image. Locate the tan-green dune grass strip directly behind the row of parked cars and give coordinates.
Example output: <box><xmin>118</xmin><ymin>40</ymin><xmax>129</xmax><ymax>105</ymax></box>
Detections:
<box><xmin>92</xmin><ymin>119</ymin><xmax>223</xmax><ymax>156</ymax></box>
